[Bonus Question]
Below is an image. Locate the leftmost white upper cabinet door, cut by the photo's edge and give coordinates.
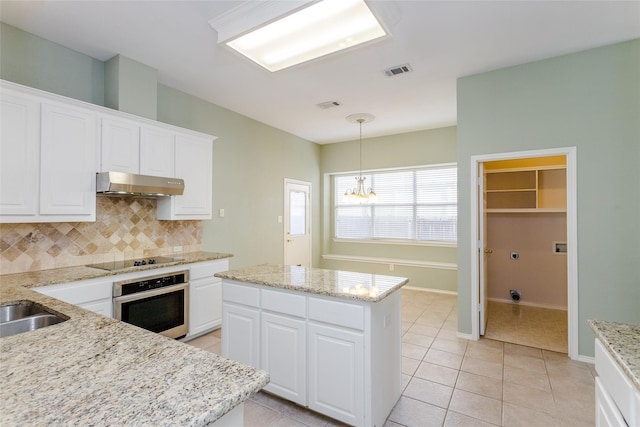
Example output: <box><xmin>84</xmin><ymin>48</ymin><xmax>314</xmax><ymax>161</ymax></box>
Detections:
<box><xmin>0</xmin><ymin>90</ymin><xmax>40</xmax><ymax>217</ymax></box>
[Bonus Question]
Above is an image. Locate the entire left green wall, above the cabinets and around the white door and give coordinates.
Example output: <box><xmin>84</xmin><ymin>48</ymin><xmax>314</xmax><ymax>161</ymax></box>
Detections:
<box><xmin>0</xmin><ymin>24</ymin><xmax>320</xmax><ymax>268</ymax></box>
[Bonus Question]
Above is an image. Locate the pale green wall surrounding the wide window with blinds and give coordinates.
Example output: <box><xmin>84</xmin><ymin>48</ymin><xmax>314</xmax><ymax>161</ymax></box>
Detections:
<box><xmin>320</xmin><ymin>127</ymin><xmax>457</xmax><ymax>292</ymax></box>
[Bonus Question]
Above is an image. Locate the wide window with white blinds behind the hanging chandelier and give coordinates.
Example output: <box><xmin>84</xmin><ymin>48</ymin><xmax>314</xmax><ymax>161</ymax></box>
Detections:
<box><xmin>334</xmin><ymin>165</ymin><xmax>458</xmax><ymax>242</ymax></box>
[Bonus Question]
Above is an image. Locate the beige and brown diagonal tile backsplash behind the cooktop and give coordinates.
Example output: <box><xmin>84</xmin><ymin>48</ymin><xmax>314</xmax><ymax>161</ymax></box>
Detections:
<box><xmin>0</xmin><ymin>197</ymin><xmax>202</xmax><ymax>274</ymax></box>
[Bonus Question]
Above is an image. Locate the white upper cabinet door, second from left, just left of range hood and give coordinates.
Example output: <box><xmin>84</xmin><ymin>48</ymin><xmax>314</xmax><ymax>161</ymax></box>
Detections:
<box><xmin>40</xmin><ymin>103</ymin><xmax>97</xmax><ymax>221</ymax></box>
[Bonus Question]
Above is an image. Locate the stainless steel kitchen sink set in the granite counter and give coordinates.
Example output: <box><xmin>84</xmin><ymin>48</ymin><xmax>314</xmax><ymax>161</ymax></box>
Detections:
<box><xmin>0</xmin><ymin>301</ymin><xmax>68</xmax><ymax>337</ymax></box>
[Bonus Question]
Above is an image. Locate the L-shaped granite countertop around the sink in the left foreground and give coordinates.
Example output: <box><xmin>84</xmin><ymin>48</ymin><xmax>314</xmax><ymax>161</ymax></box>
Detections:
<box><xmin>0</xmin><ymin>253</ymin><xmax>269</xmax><ymax>426</ymax></box>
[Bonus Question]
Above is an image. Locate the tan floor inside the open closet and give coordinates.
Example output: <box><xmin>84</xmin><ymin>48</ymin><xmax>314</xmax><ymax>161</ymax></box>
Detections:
<box><xmin>484</xmin><ymin>301</ymin><xmax>569</xmax><ymax>354</ymax></box>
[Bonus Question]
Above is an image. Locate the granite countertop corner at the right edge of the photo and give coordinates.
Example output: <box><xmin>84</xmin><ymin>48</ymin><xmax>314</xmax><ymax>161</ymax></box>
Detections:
<box><xmin>589</xmin><ymin>320</ymin><xmax>640</xmax><ymax>390</ymax></box>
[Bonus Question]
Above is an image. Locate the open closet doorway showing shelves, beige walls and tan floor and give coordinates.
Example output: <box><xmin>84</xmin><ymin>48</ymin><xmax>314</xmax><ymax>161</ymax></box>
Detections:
<box><xmin>482</xmin><ymin>156</ymin><xmax>568</xmax><ymax>353</ymax></box>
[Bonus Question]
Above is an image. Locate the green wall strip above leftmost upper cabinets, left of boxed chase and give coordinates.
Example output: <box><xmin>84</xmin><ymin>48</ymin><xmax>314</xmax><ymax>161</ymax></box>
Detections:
<box><xmin>0</xmin><ymin>22</ymin><xmax>104</xmax><ymax>105</ymax></box>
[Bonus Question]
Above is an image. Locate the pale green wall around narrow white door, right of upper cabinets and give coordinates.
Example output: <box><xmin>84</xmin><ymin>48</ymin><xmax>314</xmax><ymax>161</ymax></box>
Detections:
<box><xmin>158</xmin><ymin>85</ymin><xmax>320</xmax><ymax>268</ymax></box>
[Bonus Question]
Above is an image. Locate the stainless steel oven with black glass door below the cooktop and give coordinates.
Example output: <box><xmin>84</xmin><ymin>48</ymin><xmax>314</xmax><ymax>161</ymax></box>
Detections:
<box><xmin>113</xmin><ymin>270</ymin><xmax>189</xmax><ymax>338</ymax></box>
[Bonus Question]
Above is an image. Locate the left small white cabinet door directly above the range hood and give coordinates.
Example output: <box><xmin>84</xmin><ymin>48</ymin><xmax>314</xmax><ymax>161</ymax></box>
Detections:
<box><xmin>100</xmin><ymin>117</ymin><xmax>140</xmax><ymax>173</ymax></box>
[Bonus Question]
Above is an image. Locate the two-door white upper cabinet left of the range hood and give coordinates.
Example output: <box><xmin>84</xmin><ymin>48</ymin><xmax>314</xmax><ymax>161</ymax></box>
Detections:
<box><xmin>0</xmin><ymin>81</ymin><xmax>98</xmax><ymax>223</ymax></box>
